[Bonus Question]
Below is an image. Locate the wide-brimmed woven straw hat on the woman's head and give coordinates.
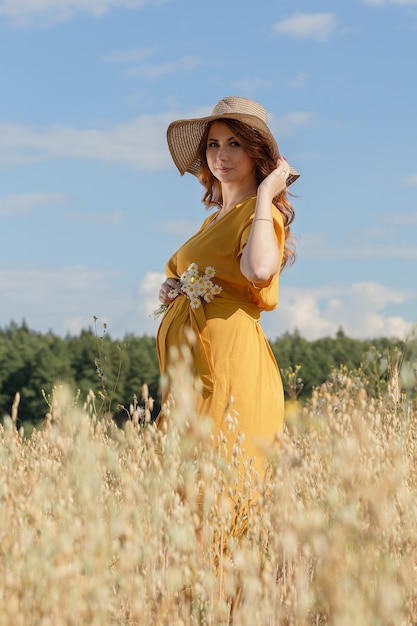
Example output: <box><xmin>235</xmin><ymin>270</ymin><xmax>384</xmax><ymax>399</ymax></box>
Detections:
<box><xmin>167</xmin><ymin>96</ymin><xmax>300</xmax><ymax>186</ymax></box>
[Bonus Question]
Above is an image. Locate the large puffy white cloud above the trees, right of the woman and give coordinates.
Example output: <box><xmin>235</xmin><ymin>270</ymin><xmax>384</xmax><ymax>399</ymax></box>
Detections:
<box><xmin>262</xmin><ymin>282</ymin><xmax>416</xmax><ymax>341</ymax></box>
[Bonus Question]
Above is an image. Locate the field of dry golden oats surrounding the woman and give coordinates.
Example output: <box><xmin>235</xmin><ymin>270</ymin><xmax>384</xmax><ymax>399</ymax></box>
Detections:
<box><xmin>0</xmin><ymin>344</ymin><xmax>417</xmax><ymax>626</ymax></box>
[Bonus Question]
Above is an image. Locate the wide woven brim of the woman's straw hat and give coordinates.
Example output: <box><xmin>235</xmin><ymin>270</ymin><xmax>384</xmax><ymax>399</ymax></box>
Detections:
<box><xmin>167</xmin><ymin>113</ymin><xmax>300</xmax><ymax>186</ymax></box>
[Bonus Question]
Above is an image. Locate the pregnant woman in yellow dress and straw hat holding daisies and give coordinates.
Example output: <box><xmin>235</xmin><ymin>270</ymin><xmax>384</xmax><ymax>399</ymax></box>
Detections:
<box><xmin>157</xmin><ymin>96</ymin><xmax>299</xmax><ymax>470</ymax></box>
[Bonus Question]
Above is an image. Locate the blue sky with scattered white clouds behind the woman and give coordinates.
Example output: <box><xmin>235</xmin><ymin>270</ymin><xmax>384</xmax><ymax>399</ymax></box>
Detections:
<box><xmin>0</xmin><ymin>0</ymin><xmax>417</xmax><ymax>340</ymax></box>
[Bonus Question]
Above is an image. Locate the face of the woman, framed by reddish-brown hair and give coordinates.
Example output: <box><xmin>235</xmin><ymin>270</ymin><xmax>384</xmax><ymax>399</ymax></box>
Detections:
<box><xmin>206</xmin><ymin>122</ymin><xmax>256</xmax><ymax>185</ymax></box>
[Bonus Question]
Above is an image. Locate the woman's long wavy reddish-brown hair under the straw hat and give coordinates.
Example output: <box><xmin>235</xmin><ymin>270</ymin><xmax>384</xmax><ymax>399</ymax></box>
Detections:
<box><xmin>198</xmin><ymin>119</ymin><xmax>296</xmax><ymax>269</ymax></box>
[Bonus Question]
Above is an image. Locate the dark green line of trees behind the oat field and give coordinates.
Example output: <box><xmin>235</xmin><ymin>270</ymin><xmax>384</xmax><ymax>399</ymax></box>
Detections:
<box><xmin>0</xmin><ymin>322</ymin><xmax>408</xmax><ymax>427</ymax></box>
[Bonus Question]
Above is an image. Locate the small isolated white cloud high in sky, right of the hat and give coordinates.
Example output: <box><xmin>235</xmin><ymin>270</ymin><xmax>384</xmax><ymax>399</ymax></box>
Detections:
<box><xmin>274</xmin><ymin>11</ymin><xmax>337</xmax><ymax>41</ymax></box>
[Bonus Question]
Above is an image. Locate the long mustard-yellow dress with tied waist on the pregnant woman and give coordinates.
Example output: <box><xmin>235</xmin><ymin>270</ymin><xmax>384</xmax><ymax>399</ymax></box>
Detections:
<box><xmin>157</xmin><ymin>196</ymin><xmax>284</xmax><ymax>470</ymax></box>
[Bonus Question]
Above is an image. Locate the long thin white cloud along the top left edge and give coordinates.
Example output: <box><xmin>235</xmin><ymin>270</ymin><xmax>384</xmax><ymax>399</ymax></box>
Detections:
<box><xmin>0</xmin><ymin>0</ymin><xmax>162</xmax><ymax>24</ymax></box>
